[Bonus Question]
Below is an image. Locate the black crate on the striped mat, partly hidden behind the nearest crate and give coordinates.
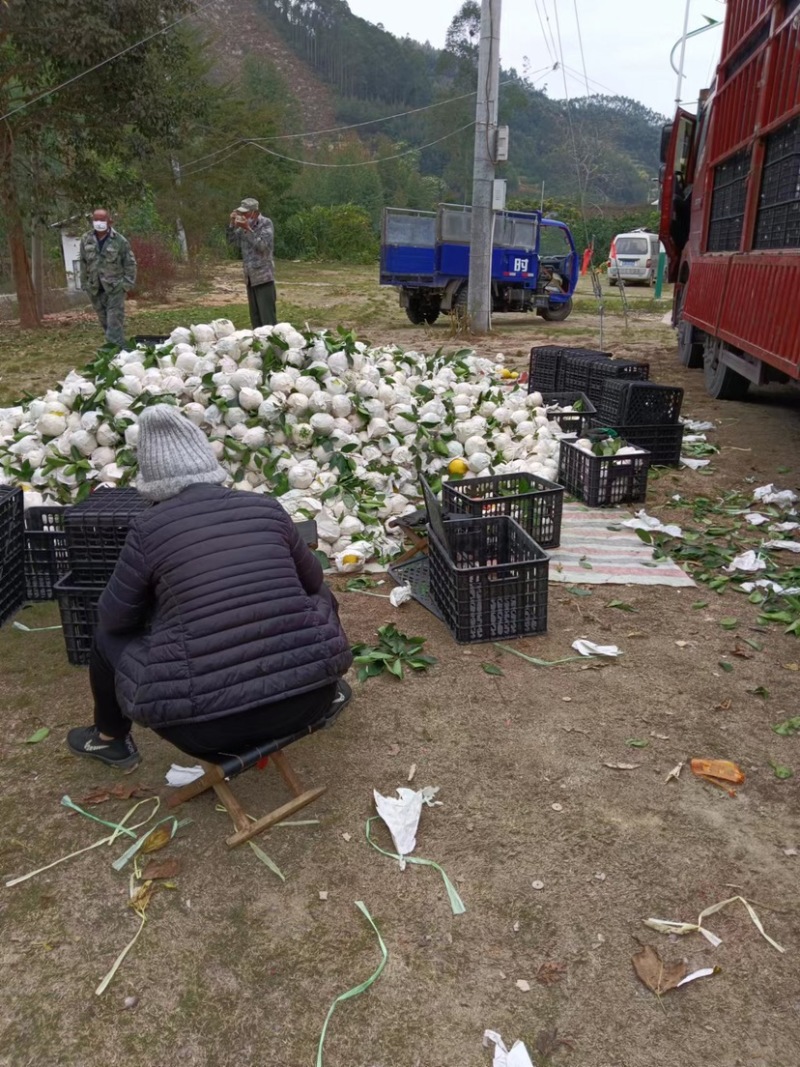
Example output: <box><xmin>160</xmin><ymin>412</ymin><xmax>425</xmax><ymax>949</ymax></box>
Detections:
<box><xmin>438</xmin><ymin>474</ymin><xmax>564</xmax><ymax>548</ymax></box>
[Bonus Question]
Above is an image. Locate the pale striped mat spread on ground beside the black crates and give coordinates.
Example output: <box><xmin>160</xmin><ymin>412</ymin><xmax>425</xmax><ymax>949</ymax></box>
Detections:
<box><xmin>548</xmin><ymin>504</ymin><xmax>695</xmax><ymax>588</ymax></box>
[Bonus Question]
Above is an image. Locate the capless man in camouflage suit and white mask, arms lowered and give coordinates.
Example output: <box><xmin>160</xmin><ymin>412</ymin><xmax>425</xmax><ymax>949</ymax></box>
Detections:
<box><xmin>80</xmin><ymin>208</ymin><xmax>137</xmax><ymax>348</ymax></box>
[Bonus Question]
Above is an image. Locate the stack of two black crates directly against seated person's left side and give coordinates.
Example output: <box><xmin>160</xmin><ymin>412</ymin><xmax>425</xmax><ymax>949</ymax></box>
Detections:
<box><xmin>55</xmin><ymin>489</ymin><xmax>150</xmax><ymax>666</ymax></box>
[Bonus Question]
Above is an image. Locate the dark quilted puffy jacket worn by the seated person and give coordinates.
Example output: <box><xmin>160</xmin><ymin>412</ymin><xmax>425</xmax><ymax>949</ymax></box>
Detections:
<box><xmin>98</xmin><ymin>484</ymin><xmax>352</xmax><ymax>729</ymax></box>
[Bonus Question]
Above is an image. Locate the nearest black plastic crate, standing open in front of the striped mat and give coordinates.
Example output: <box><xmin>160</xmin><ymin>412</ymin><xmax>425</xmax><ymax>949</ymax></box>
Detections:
<box><xmin>429</xmin><ymin>515</ymin><xmax>549</xmax><ymax>643</ymax></box>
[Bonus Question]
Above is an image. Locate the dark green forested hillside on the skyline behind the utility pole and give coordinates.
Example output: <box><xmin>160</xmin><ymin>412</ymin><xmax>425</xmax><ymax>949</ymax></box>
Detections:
<box><xmin>254</xmin><ymin>0</ymin><xmax>665</xmax><ymax>205</ymax></box>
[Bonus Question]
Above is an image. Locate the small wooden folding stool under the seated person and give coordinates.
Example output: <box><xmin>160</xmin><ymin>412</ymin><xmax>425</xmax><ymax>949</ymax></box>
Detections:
<box><xmin>167</xmin><ymin>683</ymin><xmax>351</xmax><ymax>848</ymax></box>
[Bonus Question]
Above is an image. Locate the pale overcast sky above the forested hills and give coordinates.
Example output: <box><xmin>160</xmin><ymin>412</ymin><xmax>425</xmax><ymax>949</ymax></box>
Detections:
<box><xmin>348</xmin><ymin>0</ymin><xmax>724</xmax><ymax>115</ymax></box>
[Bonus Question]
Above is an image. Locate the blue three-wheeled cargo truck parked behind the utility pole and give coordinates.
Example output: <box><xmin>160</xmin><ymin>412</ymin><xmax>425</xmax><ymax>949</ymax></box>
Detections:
<box><xmin>381</xmin><ymin>204</ymin><xmax>578</xmax><ymax>325</ymax></box>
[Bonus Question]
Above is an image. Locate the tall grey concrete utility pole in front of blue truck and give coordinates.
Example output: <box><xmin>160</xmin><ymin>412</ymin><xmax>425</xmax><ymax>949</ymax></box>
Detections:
<box><xmin>467</xmin><ymin>0</ymin><xmax>502</xmax><ymax>334</ymax></box>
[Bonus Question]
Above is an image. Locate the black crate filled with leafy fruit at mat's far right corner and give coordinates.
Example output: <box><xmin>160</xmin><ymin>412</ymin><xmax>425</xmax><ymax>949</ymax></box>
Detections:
<box><xmin>558</xmin><ymin>441</ymin><xmax>651</xmax><ymax>508</ymax></box>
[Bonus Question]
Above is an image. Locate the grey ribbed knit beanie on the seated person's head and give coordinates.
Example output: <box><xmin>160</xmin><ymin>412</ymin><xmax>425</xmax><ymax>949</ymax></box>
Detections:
<box><xmin>137</xmin><ymin>403</ymin><xmax>227</xmax><ymax>500</ymax></box>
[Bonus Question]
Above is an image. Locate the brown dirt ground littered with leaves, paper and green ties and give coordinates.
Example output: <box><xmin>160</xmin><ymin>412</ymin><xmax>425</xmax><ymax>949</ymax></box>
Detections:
<box><xmin>0</xmin><ymin>277</ymin><xmax>800</xmax><ymax>1067</ymax></box>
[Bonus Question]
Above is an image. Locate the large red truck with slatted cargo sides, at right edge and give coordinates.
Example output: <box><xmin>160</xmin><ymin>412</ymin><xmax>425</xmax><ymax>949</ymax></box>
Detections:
<box><xmin>659</xmin><ymin>0</ymin><xmax>800</xmax><ymax>400</ymax></box>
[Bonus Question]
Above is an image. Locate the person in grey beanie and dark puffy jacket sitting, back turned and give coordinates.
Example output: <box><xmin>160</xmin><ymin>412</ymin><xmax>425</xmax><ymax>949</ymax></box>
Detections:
<box><xmin>67</xmin><ymin>404</ymin><xmax>353</xmax><ymax>771</ymax></box>
